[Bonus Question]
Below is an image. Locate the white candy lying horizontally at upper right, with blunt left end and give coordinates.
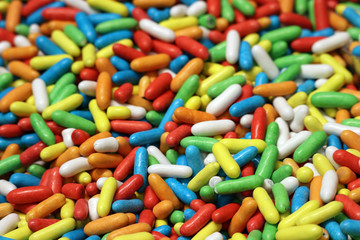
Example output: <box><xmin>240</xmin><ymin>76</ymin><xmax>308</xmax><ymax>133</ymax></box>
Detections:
<box><xmin>300</xmin><ymin>64</ymin><xmax>334</xmax><ymax>79</ymax></box>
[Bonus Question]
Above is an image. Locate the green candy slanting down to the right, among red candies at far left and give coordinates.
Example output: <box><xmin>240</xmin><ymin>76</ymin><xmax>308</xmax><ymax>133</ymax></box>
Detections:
<box><xmin>30</xmin><ymin>113</ymin><xmax>56</xmax><ymax>146</ymax></box>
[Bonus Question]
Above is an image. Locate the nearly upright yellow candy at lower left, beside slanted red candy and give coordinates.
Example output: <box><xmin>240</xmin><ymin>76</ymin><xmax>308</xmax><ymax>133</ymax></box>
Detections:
<box><xmin>97</xmin><ymin>177</ymin><xmax>117</xmax><ymax>217</ymax></box>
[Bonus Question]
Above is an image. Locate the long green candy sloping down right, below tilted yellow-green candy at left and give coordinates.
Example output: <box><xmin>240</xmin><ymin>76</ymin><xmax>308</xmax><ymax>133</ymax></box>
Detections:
<box><xmin>51</xmin><ymin>110</ymin><xmax>96</xmax><ymax>135</ymax></box>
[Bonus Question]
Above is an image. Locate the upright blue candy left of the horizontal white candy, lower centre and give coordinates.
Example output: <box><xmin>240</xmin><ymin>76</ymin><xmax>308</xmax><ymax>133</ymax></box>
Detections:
<box><xmin>134</xmin><ymin>147</ymin><xmax>149</xmax><ymax>193</ymax></box>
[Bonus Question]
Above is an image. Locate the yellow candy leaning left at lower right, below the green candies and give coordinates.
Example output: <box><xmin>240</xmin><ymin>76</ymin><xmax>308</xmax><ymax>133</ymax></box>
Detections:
<box><xmin>253</xmin><ymin>187</ymin><xmax>280</xmax><ymax>224</ymax></box>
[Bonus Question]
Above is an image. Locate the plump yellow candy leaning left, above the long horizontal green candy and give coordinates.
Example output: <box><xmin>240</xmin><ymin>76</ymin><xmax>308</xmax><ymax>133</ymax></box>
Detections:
<box><xmin>212</xmin><ymin>142</ymin><xmax>240</xmax><ymax>178</ymax></box>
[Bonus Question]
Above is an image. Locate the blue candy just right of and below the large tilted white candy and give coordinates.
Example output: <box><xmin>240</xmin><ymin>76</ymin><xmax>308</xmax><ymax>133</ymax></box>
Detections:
<box><xmin>229</xmin><ymin>95</ymin><xmax>265</xmax><ymax>117</ymax></box>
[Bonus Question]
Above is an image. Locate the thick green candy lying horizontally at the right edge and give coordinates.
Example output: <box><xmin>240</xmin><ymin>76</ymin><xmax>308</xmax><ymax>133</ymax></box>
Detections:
<box><xmin>311</xmin><ymin>92</ymin><xmax>359</xmax><ymax>109</ymax></box>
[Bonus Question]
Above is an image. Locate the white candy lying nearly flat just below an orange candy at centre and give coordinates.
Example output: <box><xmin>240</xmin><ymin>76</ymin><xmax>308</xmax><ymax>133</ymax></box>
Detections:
<box><xmin>191</xmin><ymin>119</ymin><xmax>235</xmax><ymax>136</ymax></box>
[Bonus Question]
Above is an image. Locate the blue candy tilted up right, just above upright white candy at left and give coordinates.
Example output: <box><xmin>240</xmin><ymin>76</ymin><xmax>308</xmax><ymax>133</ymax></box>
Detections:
<box><xmin>40</xmin><ymin>58</ymin><xmax>73</xmax><ymax>86</ymax></box>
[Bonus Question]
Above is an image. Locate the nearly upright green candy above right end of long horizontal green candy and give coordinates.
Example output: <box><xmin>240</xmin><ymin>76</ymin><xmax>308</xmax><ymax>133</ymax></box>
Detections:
<box><xmin>255</xmin><ymin>145</ymin><xmax>279</xmax><ymax>179</ymax></box>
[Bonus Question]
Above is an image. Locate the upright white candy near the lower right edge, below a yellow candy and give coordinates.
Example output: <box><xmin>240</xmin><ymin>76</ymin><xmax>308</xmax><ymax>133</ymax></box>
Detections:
<box><xmin>320</xmin><ymin>170</ymin><xmax>339</xmax><ymax>203</ymax></box>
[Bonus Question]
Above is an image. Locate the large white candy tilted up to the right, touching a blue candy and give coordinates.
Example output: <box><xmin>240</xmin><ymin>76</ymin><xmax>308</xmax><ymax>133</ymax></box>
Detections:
<box><xmin>206</xmin><ymin>84</ymin><xmax>241</xmax><ymax>117</ymax></box>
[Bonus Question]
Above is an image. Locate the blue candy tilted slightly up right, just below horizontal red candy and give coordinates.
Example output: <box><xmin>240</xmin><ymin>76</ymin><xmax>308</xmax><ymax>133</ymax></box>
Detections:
<box><xmin>129</xmin><ymin>128</ymin><xmax>165</xmax><ymax>146</ymax></box>
